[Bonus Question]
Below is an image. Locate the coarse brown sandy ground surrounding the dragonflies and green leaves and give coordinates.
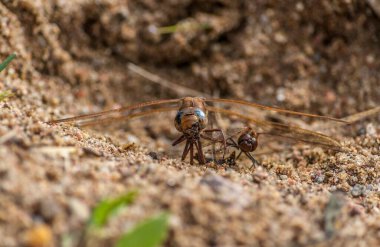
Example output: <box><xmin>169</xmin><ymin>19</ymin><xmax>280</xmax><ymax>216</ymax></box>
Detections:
<box><xmin>0</xmin><ymin>0</ymin><xmax>380</xmax><ymax>247</ymax></box>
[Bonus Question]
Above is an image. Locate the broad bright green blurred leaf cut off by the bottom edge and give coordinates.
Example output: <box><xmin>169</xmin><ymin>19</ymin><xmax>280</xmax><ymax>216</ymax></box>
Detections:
<box><xmin>115</xmin><ymin>213</ymin><xmax>169</xmax><ymax>247</ymax></box>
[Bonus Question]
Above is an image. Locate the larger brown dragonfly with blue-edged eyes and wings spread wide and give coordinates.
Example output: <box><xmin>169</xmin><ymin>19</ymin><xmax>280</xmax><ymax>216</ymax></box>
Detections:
<box><xmin>48</xmin><ymin>97</ymin><xmax>349</xmax><ymax>164</ymax></box>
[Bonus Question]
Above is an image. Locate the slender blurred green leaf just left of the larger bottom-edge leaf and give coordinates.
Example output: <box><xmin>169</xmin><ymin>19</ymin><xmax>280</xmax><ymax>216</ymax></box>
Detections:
<box><xmin>90</xmin><ymin>191</ymin><xmax>137</xmax><ymax>227</ymax></box>
